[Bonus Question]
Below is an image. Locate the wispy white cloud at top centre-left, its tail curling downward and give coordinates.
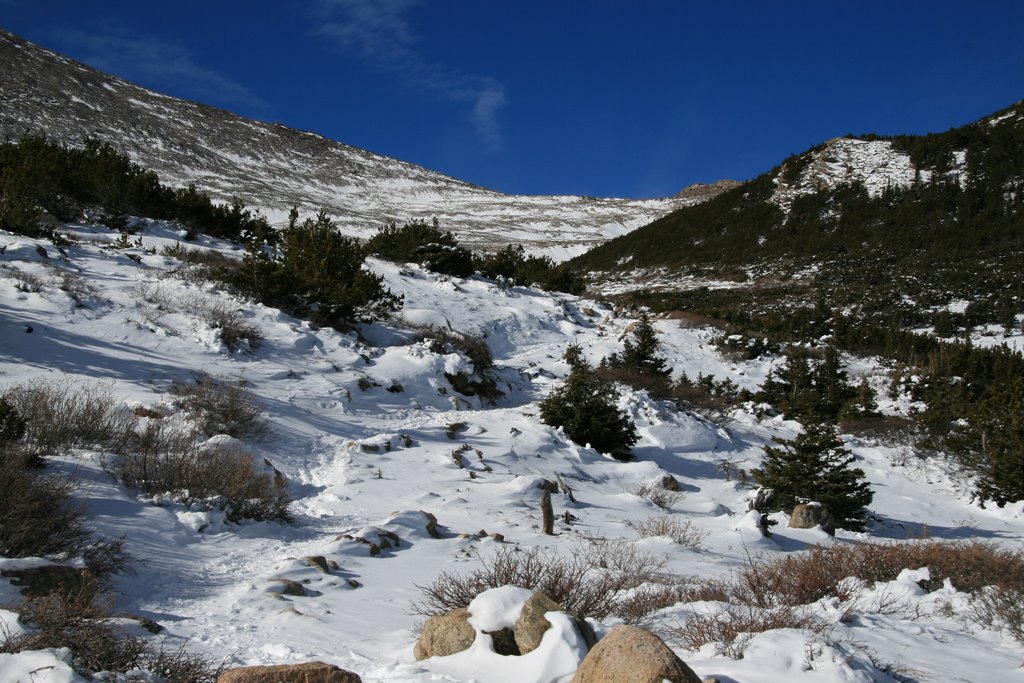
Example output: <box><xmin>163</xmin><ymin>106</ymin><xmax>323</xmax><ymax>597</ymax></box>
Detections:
<box><xmin>313</xmin><ymin>0</ymin><xmax>507</xmax><ymax>150</ymax></box>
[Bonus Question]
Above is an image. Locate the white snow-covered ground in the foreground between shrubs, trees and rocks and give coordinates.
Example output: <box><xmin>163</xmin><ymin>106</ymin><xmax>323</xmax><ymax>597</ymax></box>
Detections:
<box><xmin>0</xmin><ymin>224</ymin><xmax>1024</xmax><ymax>683</ymax></box>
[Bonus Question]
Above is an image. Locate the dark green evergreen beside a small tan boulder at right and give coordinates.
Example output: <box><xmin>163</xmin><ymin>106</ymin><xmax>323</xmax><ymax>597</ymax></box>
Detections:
<box><xmin>752</xmin><ymin>424</ymin><xmax>873</xmax><ymax>531</ymax></box>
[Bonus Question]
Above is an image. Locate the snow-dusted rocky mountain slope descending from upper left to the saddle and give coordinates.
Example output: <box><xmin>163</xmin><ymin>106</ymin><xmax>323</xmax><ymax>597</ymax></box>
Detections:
<box><xmin>0</xmin><ymin>31</ymin><xmax>716</xmax><ymax>260</ymax></box>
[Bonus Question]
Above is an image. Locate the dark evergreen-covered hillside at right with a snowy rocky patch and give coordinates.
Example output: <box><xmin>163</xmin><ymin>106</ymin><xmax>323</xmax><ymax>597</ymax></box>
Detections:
<box><xmin>573</xmin><ymin>101</ymin><xmax>1024</xmax><ymax>290</ymax></box>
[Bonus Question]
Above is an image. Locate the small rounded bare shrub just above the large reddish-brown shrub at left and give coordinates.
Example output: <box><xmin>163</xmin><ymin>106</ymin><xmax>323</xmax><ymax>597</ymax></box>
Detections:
<box><xmin>170</xmin><ymin>373</ymin><xmax>268</xmax><ymax>439</ymax></box>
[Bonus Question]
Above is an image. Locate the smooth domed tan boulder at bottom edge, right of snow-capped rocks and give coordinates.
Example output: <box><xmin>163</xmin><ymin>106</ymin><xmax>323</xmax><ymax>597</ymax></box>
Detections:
<box><xmin>572</xmin><ymin>626</ymin><xmax>700</xmax><ymax>683</ymax></box>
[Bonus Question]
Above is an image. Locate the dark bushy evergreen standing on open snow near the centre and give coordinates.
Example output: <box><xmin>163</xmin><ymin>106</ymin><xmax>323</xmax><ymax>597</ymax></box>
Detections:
<box><xmin>541</xmin><ymin>344</ymin><xmax>637</xmax><ymax>461</ymax></box>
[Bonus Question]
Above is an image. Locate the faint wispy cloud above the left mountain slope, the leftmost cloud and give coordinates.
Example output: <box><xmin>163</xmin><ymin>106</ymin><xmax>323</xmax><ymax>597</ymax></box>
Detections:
<box><xmin>51</xmin><ymin>26</ymin><xmax>271</xmax><ymax>112</ymax></box>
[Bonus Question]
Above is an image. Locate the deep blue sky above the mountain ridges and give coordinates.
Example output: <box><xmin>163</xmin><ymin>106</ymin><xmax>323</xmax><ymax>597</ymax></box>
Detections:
<box><xmin>0</xmin><ymin>0</ymin><xmax>1024</xmax><ymax>197</ymax></box>
